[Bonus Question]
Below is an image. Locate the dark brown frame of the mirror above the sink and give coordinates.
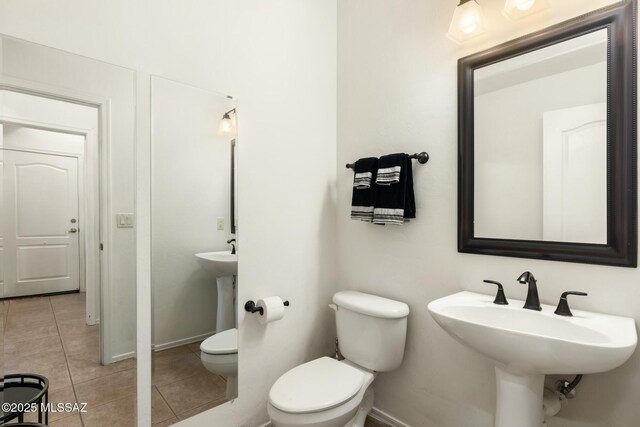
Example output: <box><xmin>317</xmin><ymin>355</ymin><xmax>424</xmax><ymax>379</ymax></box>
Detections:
<box><xmin>458</xmin><ymin>0</ymin><xmax>638</xmax><ymax>267</ymax></box>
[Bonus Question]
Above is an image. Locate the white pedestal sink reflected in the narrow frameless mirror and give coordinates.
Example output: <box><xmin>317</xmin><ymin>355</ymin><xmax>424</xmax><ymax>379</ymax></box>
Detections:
<box><xmin>196</xmin><ymin>251</ymin><xmax>238</xmax><ymax>333</ymax></box>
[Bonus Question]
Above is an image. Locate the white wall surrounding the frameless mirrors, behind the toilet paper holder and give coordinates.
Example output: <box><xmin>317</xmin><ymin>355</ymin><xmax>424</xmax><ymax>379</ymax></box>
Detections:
<box><xmin>0</xmin><ymin>0</ymin><xmax>337</xmax><ymax>426</ymax></box>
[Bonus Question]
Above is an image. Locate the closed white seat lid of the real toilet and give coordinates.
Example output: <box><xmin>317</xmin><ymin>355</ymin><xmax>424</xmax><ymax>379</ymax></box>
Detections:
<box><xmin>269</xmin><ymin>357</ymin><xmax>365</xmax><ymax>414</ymax></box>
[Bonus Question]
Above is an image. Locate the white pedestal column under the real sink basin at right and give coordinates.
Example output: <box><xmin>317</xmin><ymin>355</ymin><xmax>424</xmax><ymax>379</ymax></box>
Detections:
<box><xmin>494</xmin><ymin>366</ymin><xmax>544</xmax><ymax>427</ymax></box>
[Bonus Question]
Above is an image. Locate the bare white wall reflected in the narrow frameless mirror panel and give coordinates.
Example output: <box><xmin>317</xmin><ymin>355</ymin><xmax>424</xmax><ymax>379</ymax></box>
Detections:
<box><xmin>151</xmin><ymin>77</ymin><xmax>234</xmax><ymax>346</ymax></box>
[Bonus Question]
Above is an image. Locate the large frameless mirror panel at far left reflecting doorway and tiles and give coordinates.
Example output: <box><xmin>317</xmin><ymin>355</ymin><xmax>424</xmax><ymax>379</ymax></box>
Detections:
<box><xmin>0</xmin><ymin>36</ymin><xmax>136</xmax><ymax>425</ymax></box>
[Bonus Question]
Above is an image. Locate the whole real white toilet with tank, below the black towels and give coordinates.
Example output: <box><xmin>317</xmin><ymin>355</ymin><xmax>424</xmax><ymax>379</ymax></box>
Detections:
<box><xmin>267</xmin><ymin>291</ymin><xmax>409</xmax><ymax>427</ymax></box>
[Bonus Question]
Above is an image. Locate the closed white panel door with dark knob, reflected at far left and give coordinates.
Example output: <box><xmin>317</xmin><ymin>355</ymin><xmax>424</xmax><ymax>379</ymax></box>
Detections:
<box><xmin>2</xmin><ymin>150</ymin><xmax>80</xmax><ymax>297</ymax></box>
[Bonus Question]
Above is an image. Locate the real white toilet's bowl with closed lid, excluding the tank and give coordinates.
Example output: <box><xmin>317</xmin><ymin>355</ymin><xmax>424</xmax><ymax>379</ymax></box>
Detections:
<box><xmin>267</xmin><ymin>357</ymin><xmax>376</xmax><ymax>427</ymax></box>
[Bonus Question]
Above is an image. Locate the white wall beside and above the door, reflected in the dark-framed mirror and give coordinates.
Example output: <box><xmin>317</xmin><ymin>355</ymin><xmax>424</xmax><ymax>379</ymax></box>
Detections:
<box><xmin>474</xmin><ymin>61</ymin><xmax>607</xmax><ymax>240</ymax></box>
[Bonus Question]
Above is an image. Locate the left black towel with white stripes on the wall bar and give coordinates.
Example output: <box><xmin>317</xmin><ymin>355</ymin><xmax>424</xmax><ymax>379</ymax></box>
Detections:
<box><xmin>351</xmin><ymin>157</ymin><xmax>378</xmax><ymax>222</ymax></box>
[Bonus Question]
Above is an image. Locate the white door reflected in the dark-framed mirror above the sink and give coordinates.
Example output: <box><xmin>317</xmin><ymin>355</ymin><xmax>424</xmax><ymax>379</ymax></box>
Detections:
<box><xmin>542</xmin><ymin>104</ymin><xmax>607</xmax><ymax>244</ymax></box>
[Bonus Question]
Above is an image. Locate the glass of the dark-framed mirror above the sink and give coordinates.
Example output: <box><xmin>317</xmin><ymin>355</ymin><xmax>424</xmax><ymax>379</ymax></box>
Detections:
<box><xmin>473</xmin><ymin>29</ymin><xmax>607</xmax><ymax>244</ymax></box>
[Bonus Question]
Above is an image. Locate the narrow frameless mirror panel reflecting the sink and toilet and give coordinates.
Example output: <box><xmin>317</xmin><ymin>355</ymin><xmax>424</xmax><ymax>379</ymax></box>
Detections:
<box><xmin>151</xmin><ymin>76</ymin><xmax>238</xmax><ymax>419</ymax></box>
